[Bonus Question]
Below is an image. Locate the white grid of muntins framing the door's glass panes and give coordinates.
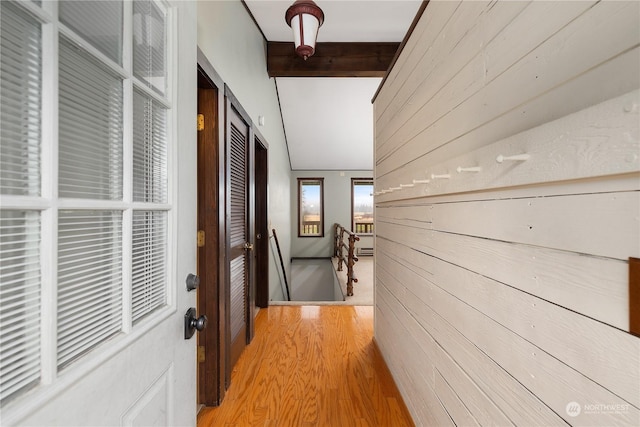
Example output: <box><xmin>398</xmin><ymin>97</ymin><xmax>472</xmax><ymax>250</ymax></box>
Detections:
<box><xmin>0</xmin><ymin>0</ymin><xmax>178</xmax><ymax>406</ymax></box>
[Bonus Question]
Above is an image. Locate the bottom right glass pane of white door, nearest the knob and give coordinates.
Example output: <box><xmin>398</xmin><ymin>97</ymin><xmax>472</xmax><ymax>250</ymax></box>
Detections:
<box><xmin>132</xmin><ymin>212</ymin><xmax>167</xmax><ymax>323</ymax></box>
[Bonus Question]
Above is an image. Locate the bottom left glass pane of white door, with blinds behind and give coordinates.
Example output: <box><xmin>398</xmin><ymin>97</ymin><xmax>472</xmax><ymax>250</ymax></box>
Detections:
<box><xmin>0</xmin><ymin>211</ymin><xmax>41</xmax><ymax>404</ymax></box>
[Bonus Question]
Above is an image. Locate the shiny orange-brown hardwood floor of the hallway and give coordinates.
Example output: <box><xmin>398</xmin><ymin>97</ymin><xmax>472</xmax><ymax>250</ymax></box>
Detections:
<box><xmin>198</xmin><ymin>306</ymin><xmax>414</xmax><ymax>427</ymax></box>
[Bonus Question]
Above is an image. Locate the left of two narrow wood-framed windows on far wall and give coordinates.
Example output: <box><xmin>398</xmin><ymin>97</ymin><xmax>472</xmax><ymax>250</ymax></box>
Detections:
<box><xmin>298</xmin><ymin>178</ymin><xmax>324</xmax><ymax>237</ymax></box>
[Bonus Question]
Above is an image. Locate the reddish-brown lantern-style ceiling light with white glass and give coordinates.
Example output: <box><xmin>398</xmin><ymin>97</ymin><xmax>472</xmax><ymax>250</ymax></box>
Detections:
<box><xmin>284</xmin><ymin>0</ymin><xmax>324</xmax><ymax>60</ymax></box>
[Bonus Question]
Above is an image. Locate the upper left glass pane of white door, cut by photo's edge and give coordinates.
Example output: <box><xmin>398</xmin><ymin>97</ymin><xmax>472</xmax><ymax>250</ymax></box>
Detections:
<box><xmin>0</xmin><ymin>1</ymin><xmax>42</xmax><ymax>196</ymax></box>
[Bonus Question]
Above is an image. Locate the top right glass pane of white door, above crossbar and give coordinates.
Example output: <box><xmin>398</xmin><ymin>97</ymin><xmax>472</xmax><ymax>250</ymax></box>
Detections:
<box><xmin>133</xmin><ymin>0</ymin><xmax>167</xmax><ymax>94</ymax></box>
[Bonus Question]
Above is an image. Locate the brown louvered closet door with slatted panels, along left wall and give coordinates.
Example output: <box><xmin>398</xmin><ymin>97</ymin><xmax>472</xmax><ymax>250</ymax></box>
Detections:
<box><xmin>229</xmin><ymin>108</ymin><xmax>249</xmax><ymax>367</ymax></box>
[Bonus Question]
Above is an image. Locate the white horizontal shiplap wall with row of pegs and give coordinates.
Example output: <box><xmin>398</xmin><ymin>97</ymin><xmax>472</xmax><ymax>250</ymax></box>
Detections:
<box><xmin>374</xmin><ymin>1</ymin><xmax>640</xmax><ymax>426</ymax></box>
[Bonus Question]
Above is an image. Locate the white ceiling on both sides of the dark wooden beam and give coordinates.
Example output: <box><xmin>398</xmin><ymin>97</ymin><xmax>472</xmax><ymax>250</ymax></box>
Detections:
<box><xmin>245</xmin><ymin>0</ymin><xmax>422</xmax><ymax>170</ymax></box>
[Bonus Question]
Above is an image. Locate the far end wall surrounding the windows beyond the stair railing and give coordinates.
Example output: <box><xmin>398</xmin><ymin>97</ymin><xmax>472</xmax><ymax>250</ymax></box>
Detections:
<box><xmin>290</xmin><ymin>170</ymin><xmax>373</xmax><ymax>258</ymax></box>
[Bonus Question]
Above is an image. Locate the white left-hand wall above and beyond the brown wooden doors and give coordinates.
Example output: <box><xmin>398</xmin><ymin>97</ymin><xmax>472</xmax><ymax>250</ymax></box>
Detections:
<box><xmin>198</xmin><ymin>0</ymin><xmax>291</xmax><ymax>299</ymax></box>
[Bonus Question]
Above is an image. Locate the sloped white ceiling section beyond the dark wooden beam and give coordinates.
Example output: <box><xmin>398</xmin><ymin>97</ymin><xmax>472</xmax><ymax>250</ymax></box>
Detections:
<box><xmin>277</xmin><ymin>77</ymin><xmax>382</xmax><ymax>170</ymax></box>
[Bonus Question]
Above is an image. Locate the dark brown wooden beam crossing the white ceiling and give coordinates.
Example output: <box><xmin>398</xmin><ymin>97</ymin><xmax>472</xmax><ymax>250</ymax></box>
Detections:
<box><xmin>267</xmin><ymin>42</ymin><xmax>400</xmax><ymax>77</ymax></box>
